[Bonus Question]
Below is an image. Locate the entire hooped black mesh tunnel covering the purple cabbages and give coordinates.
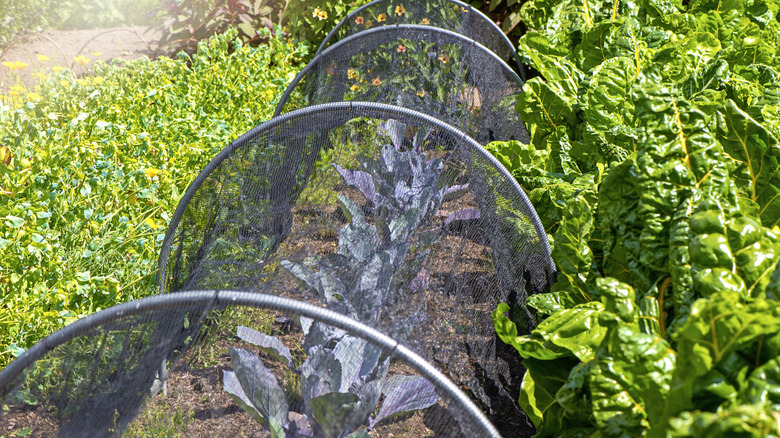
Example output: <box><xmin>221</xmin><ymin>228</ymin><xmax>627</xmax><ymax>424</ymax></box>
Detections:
<box><xmin>0</xmin><ymin>0</ymin><xmax>555</xmax><ymax>438</ymax></box>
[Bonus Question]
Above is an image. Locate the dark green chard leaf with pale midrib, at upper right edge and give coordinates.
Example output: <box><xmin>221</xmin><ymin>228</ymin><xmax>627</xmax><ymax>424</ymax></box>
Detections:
<box><xmin>718</xmin><ymin>100</ymin><xmax>780</xmax><ymax>228</ymax></box>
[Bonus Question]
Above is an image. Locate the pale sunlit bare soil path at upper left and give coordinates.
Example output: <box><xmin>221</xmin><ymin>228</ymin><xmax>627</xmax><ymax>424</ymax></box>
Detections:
<box><xmin>0</xmin><ymin>26</ymin><xmax>160</xmax><ymax>93</ymax></box>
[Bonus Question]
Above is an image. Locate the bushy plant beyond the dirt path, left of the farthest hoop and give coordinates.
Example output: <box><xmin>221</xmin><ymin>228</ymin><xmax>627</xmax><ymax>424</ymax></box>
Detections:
<box><xmin>153</xmin><ymin>0</ymin><xmax>289</xmax><ymax>54</ymax></box>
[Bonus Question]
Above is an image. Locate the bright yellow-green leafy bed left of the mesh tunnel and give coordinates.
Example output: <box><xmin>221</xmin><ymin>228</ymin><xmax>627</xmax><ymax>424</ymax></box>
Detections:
<box><xmin>0</xmin><ymin>31</ymin><xmax>306</xmax><ymax>365</ymax></box>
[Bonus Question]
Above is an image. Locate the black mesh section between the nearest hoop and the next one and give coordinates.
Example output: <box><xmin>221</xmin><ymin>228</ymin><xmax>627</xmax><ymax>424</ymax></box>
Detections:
<box><xmin>155</xmin><ymin>102</ymin><xmax>553</xmax><ymax>434</ymax></box>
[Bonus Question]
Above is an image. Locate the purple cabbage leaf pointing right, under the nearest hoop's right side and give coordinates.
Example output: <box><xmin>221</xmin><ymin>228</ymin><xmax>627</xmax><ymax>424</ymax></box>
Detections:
<box><xmin>369</xmin><ymin>375</ymin><xmax>439</xmax><ymax>429</ymax></box>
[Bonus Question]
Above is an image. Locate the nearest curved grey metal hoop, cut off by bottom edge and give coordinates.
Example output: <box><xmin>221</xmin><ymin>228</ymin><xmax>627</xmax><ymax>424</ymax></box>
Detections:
<box><xmin>0</xmin><ymin>290</ymin><xmax>501</xmax><ymax>437</ymax></box>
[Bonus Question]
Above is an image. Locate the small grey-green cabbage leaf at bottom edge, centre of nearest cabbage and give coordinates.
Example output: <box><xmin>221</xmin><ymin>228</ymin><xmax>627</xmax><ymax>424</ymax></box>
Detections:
<box><xmin>310</xmin><ymin>392</ymin><xmax>363</xmax><ymax>438</ymax></box>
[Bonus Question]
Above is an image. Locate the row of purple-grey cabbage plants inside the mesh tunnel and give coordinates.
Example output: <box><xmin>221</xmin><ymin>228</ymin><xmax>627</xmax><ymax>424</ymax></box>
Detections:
<box><xmin>219</xmin><ymin>120</ymin><xmax>478</xmax><ymax>437</ymax></box>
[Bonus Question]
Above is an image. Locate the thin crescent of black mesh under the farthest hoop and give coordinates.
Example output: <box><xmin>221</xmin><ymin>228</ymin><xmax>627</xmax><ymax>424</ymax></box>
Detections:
<box><xmin>317</xmin><ymin>0</ymin><xmax>523</xmax><ymax>76</ymax></box>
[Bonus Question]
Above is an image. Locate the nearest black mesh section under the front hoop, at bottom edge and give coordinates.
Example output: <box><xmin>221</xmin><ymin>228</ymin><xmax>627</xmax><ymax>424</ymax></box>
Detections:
<box><xmin>0</xmin><ymin>291</ymin><xmax>498</xmax><ymax>438</ymax></box>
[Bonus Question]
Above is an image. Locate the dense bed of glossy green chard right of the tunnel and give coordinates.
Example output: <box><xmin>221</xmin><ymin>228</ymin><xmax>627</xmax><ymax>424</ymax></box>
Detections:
<box><xmin>490</xmin><ymin>0</ymin><xmax>780</xmax><ymax>437</ymax></box>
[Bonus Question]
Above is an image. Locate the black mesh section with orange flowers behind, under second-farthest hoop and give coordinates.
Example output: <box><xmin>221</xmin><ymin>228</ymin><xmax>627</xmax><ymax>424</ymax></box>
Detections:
<box><xmin>276</xmin><ymin>25</ymin><xmax>529</xmax><ymax>144</ymax></box>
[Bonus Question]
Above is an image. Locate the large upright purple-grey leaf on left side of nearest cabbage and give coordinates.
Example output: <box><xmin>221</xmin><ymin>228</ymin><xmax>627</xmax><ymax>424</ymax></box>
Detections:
<box><xmin>229</xmin><ymin>348</ymin><xmax>288</xmax><ymax>427</ymax></box>
